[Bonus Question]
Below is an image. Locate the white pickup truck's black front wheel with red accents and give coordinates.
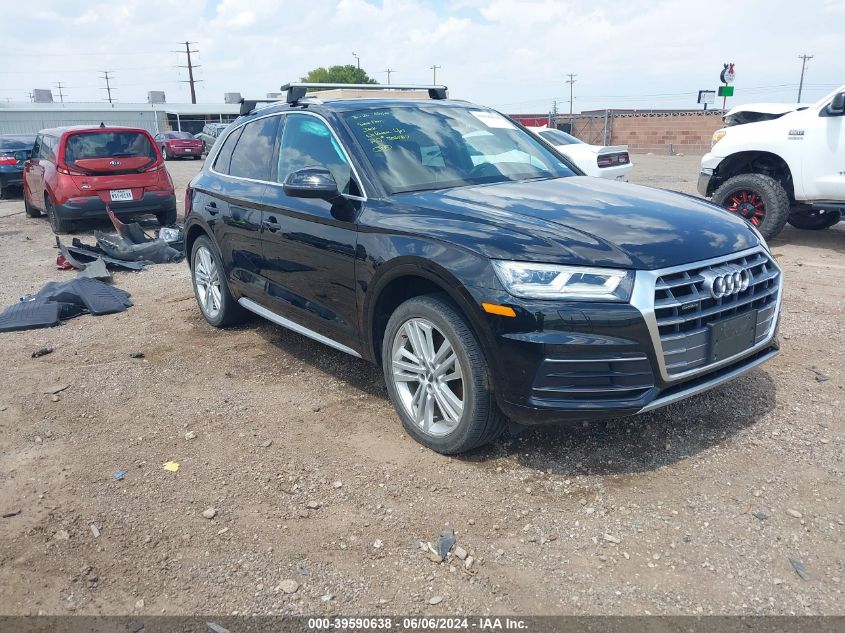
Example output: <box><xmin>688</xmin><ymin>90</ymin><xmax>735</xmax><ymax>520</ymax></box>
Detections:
<box><xmin>713</xmin><ymin>174</ymin><xmax>789</xmax><ymax>240</ymax></box>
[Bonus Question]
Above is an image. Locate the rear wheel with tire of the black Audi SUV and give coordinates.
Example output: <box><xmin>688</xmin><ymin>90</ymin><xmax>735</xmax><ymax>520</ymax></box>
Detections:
<box><xmin>191</xmin><ymin>235</ymin><xmax>246</xmax><ymax>327</ymax></box>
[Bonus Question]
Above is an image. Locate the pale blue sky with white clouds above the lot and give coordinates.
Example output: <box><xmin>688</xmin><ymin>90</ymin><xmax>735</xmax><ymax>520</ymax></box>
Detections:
<box><xmin>0</xmin><ymin>0</ymin><xmax>845</xmax><ymax>112</ymax></box>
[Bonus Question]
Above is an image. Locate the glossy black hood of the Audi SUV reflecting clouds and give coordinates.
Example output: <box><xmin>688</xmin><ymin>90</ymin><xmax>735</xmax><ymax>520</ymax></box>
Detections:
<box><xmin>387</xmin><ymin>176</ymin><xmax>759</xmax><ymax>270</ymax></box>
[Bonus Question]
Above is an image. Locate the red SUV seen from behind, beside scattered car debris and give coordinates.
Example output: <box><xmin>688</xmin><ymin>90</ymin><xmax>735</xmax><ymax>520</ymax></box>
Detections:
<box><xmin>24</xmin><ymin>126</ymin><xmax>176</xmax><ymax>233</ymax></box>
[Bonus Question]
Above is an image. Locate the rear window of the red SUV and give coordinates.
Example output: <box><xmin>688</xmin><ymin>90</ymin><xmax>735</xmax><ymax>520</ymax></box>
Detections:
<box><xmin>65</xmin><ymin>132</ymin><xmax>157</xmax><ymax>170</ymax></box>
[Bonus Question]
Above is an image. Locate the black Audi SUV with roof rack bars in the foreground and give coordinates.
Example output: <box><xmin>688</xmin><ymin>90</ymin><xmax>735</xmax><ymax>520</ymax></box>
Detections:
<box><xmin>185</xmin><ymin>84</ymin><xmax>782</xmax><ymax>453</ymax></box>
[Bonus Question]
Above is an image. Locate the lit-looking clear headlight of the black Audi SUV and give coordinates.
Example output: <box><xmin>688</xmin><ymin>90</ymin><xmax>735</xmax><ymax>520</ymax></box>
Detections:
<box><xmin>493</xmin><ymin>260</ymin><xmax>634</xmax><ymax>301</ymax></box>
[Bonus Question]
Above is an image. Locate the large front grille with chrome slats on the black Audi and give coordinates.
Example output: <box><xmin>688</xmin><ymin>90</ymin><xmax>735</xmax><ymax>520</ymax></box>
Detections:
<box><xmin>654</xmin><ymin>252</ymin><xmax>780</xmax><ymax>375</ymax></box>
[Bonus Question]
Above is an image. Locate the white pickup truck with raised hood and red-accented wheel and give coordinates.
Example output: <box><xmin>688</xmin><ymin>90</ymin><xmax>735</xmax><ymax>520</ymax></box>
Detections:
<box><xmin>698</xmin><ymin>86</ymin><xmax>845</xmax><ymax>239</ymax></box>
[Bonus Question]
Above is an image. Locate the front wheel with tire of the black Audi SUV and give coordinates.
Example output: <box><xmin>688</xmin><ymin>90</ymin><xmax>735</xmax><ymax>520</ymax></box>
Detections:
<box><xmin>382</xmin><ymin>295</ymin><xmax>505</xmax><ymax>455</ymax></box>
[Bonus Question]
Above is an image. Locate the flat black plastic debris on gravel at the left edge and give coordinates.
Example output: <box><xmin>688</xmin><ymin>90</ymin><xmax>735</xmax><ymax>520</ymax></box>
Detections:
<box><xmin>0</xmin><ymin>277</ymin><xmax>132</xmax><ymax>332</ymax></box>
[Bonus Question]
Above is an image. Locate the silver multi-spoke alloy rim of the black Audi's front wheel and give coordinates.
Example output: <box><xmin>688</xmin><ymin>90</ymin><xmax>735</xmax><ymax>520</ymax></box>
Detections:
<box><xmin>391</xmin><ymin>318</ymin><xmax>465</xmax><ymax>437</ymax></box>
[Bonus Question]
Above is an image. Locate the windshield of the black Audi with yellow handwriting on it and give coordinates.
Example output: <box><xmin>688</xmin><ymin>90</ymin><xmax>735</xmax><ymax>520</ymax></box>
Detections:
<box><xmin>343</xmin><ymin>106</ymin><xmax>575</xmax><ymax>194</ymax></box>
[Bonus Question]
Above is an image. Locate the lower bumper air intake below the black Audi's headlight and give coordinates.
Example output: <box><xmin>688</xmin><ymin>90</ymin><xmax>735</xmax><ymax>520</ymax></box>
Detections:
<box><xmin>531</xmin><ymin>354</ymin><xmax>654</xmax><ymax>406</ymax></box>
